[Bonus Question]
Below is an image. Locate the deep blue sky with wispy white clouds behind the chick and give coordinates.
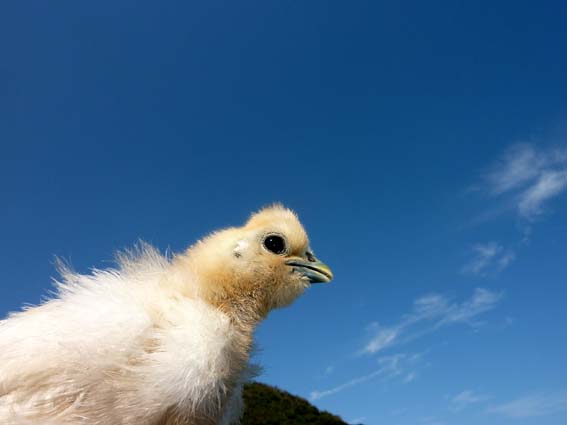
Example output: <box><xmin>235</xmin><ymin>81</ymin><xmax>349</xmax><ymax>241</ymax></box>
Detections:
<box><xmin>0</xmin><ymin>0</ymin><xmax>567</xmax><ymax>425</ymax></box>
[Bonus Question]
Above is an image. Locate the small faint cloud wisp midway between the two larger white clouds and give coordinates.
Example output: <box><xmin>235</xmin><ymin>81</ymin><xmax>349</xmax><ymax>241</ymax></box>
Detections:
<box><xmin>461</xmin><ymin>241</ymin><xmax>516</xmax><ymax>276</ymax></box>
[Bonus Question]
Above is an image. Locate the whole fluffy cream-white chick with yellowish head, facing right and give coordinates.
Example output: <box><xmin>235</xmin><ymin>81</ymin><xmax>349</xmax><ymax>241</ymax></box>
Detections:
<box><xmin>0</xmin><ymin>205</ymin><xmax>333</xmax><ymax>425</ymax></box>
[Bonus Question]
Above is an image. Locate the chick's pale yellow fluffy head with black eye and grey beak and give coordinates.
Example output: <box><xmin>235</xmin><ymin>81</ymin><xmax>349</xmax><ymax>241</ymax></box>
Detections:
<box><xmin>184</xmin><ymin>205</ymin><xmax>333</xmax><ymax>315</ymax></box>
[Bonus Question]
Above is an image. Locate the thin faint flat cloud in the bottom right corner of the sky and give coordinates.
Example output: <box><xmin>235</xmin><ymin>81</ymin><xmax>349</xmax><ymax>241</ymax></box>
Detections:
<box><xmin>487</xmin><ymin>391</ymin><xmax>567</xmax><ymax>418</ymax></box>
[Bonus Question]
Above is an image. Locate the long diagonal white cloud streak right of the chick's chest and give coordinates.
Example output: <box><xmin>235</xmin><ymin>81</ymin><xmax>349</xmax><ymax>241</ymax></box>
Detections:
<box><xmin>359</xmin><ymin>288</ymin><xmax>503</xmax><ymax>354</ymax></box>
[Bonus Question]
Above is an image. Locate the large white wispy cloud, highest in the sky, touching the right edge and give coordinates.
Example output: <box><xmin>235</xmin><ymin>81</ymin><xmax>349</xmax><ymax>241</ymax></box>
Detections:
<box><xmin>484</xmin><ymin>143</ymin><xmax>567</xmax><ymax>221</ymax></box>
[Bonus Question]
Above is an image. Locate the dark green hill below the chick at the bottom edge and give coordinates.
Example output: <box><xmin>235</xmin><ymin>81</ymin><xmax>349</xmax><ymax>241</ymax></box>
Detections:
<box><xmin>242</xmin><ymin>382</ymin><xmax>346</xmax><ymax>425</ymax></box>
